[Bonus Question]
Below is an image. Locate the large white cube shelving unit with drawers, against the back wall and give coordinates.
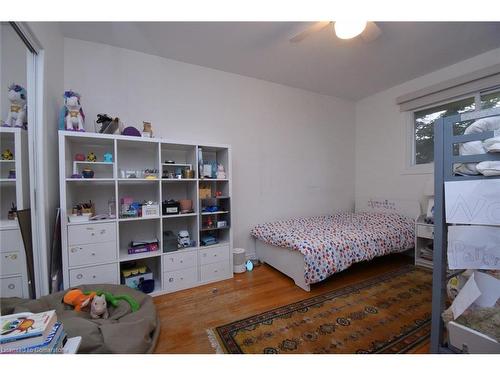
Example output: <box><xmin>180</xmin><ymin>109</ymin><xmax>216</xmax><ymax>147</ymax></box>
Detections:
<box><xmin>59</xmin><ymin>131</ymin><xmax>233</xmax><ymax>295</ymax></box>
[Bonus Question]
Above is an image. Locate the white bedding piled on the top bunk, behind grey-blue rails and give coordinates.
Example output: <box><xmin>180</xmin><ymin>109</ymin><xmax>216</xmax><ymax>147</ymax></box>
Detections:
<box><xmin>454</xmin><ymin>116</ymin><xmax>500</xmax><ymax>176</ymax></box>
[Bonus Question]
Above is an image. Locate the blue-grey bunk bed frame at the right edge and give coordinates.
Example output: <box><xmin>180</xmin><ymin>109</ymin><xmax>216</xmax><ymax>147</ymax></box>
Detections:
<box><xmin>431</xmin><ymin>108</ymin><xmax>500</xmax><ymax>354</ymax></box>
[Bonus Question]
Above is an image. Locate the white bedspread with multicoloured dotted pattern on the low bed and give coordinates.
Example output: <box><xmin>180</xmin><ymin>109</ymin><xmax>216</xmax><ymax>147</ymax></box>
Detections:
<box><xmin>251</xmin><ymin>212</ymin><xmax>415</xmax><ymax>284</ymax></box>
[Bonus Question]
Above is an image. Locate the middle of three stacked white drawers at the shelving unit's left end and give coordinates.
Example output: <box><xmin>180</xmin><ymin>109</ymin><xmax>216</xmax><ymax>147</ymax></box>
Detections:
<box><xmin>68</xmin><ymin>241</ymin><xmax>116</xmax><ymax>267</ymax></box>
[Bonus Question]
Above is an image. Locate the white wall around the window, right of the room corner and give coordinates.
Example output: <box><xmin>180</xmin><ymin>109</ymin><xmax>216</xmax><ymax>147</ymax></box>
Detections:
<box><xmin>356</xmin><ymin>49</ymin><xmax>500</xmax><ymax>212</ymax></box>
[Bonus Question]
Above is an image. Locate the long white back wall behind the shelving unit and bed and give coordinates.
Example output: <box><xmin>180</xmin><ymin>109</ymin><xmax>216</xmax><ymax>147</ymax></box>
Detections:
<box><xmin>64</xmin><ymin>39</ymin><xmax>354</xmax><ymax>252</ymax></box>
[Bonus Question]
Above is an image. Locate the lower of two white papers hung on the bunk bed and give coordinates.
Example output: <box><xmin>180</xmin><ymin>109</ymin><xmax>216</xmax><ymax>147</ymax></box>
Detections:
<box><xmin>448</xmin><ymin>225</ymin><xmax>500</xmax><ymax>270</ymax></box>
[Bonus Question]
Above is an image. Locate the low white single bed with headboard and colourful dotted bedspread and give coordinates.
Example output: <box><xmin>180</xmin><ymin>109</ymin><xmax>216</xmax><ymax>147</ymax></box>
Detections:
<box><xmin>251</xmin><ymin>199</ymin><xmax>420</xmax><ymax>291</ymax></box>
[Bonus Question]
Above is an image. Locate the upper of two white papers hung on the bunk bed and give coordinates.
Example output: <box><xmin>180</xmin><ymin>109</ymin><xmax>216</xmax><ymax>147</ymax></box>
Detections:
<box><xmin>444</xmin><ymin>179</ymin><xmax>500</xmax><ymax>225</ymax></box>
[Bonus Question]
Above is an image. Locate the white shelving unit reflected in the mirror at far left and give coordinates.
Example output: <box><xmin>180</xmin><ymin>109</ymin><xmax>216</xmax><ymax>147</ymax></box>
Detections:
<box><xmin>0</xmin><ymin>127</ymin><xmax>30</xmax><ymax>298</ymax></box>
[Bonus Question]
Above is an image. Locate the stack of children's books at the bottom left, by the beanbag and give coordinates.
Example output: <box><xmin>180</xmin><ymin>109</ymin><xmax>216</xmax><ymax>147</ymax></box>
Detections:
<box><xmin>0</xmin><ymin>310</ymin><xmax>67</xmax><ymax>354</ymax></box>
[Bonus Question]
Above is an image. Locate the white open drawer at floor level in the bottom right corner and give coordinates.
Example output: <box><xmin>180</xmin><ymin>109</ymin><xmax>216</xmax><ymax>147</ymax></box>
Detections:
<box><xmin>448</xmin><ymin>322</ymin><xmax>500</xmax><ymax>354</ymax></box>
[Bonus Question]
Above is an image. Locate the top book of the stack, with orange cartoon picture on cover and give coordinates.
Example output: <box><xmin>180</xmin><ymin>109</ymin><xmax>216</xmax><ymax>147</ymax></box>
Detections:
<box><xmin>0</xmin><ymin>310</ymin><xmax>57</xmax><ymax>350</ymax></box>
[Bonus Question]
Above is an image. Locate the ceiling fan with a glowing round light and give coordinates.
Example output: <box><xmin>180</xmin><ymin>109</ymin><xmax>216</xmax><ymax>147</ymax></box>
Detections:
<box><xmin>290</xmin><ymin>21</ymin><xmax>382</xmax><ymax>43</ymax></box>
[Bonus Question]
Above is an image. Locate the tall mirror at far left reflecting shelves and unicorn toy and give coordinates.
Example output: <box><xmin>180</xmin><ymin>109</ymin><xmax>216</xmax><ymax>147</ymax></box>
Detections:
<box><xmin>0</xmin><ymin>22</ymin><xmax>35</xmax><ymax>298</ymax></box>
